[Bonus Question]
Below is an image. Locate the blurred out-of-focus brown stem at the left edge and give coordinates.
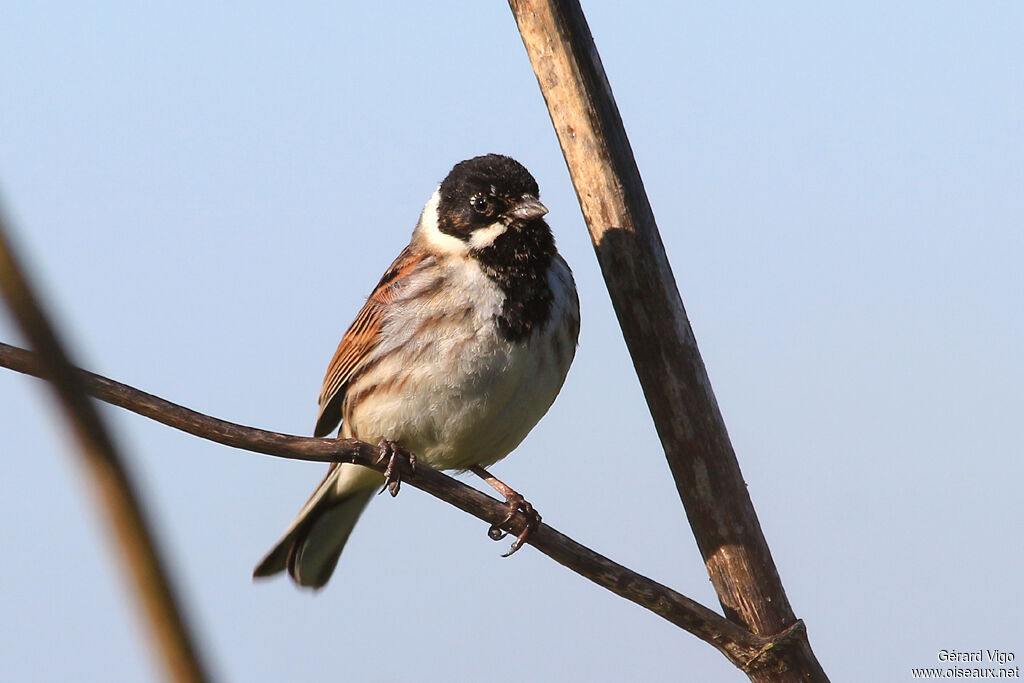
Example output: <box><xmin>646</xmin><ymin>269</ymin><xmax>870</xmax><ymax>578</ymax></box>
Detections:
<box><xmin>0</xmin><ymin>215</ymin><xmax>209</xmax><ymax>683</ymax></box>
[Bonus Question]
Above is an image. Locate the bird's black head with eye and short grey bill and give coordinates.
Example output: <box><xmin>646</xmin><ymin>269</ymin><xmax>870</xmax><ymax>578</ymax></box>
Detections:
<box><xmin>437</xmin><ymin>155</ymin><xmax>548</xmax><ymax>241</ymax></box>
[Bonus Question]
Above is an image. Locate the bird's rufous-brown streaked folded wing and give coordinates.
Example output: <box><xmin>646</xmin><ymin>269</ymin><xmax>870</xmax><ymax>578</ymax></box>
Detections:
<box><xmin>313</xmin><ymin>247</ymin><xmax>426</xmax><ymax>436</ymax></box>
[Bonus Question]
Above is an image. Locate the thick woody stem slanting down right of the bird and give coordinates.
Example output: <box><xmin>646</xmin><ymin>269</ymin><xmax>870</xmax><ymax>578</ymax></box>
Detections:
<box><xmin>509</xmin><ymin>0</ymin><xmax>827</xmax><ymax>681</ymax></box>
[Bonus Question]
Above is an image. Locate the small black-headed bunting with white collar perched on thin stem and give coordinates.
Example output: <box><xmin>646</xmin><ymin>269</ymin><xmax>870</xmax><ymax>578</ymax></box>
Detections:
<box><xmin>253</xmin><ymin>154</ymin><xmax>580</xmax><ymax>589</ymax></box>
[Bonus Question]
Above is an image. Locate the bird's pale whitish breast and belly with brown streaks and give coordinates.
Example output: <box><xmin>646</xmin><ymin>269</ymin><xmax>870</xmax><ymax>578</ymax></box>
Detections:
<box><xmin>345</xmin><ymin>256</ymin><xmax>579</xmax><ymax>469</ymax></box>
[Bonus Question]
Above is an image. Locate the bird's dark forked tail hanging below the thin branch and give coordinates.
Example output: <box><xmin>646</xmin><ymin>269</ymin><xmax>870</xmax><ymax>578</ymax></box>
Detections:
<box><xmin>253</xmin><ymin>463</ymin><xmax>384</xmax><ymax>588</ymax></box>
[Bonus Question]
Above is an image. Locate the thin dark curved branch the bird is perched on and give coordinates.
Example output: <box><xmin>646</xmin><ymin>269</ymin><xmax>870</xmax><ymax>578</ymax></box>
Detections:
<box><xmin>0</xmin><ymin>343</ymin><xmax>782</xmax><ymax>668</ymax></box>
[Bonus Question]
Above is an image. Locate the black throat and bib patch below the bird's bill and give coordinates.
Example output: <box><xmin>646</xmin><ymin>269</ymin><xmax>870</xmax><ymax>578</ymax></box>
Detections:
<box><xmin>475</xmin><ymin>220</ymin><xmax>556</xmax><ymax>342</ymax></box>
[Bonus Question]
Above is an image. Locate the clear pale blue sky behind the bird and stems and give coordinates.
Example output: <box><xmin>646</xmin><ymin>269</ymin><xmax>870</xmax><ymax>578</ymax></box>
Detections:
<box><xmin>0</xmin><ymin>1</ymin><xmax>1024</xmax><ymax>682</ymax></box>
